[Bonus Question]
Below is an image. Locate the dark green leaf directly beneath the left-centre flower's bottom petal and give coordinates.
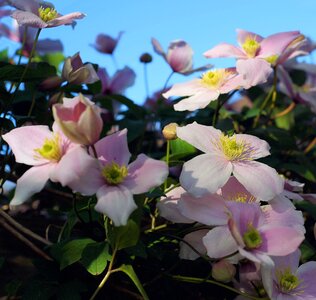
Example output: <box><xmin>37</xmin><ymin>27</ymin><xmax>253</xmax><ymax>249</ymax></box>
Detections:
<box><xmin>108</xmin><ymin>220</ymin><xmax>139</xmax><ymax>250</ymax></box>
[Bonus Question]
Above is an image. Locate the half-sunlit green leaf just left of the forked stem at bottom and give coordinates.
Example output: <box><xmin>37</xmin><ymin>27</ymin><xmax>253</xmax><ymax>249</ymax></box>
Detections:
<box><xmin>80</xmin><ymin>242</ymin><xmax>111</xmax><ymax>275</ymax></box>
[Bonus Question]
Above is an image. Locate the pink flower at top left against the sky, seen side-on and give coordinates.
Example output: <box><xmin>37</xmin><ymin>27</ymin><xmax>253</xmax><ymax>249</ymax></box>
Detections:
<box><xmin>9</xmin><ymin>0</ymin><xmax>85</xmax><ymax>28</ymax></box>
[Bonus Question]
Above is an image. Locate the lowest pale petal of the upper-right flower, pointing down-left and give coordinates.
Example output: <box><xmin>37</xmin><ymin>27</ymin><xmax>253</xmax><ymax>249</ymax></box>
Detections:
<box><xmin>173</xmin><ymin>90</ymin><xmax>219</xmax><ymax>111</ymax></box>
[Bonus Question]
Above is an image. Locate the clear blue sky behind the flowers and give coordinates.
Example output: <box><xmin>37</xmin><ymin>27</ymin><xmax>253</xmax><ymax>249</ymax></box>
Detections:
<box><xmin>0</xmin><ymin>0</ymin><xmax>316</xmax><ymax>103</ymax></box>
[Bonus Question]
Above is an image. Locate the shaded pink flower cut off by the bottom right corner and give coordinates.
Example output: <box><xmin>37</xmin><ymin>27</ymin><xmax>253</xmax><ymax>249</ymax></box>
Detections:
<box><xmin>262</xmin><ymin>250</ymin><xmax>316</xmax><ymax>300</ymax></box>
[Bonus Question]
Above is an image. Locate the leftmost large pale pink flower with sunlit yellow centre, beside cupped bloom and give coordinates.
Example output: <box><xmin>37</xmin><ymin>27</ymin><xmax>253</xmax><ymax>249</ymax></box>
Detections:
<box><xmin>2</xmin><ymin>123</ymin><xmax>76</xmax><ymax>206</ymax></box>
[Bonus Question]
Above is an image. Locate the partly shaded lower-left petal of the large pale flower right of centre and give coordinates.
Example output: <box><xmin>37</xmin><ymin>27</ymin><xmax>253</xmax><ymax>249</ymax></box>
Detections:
<box><xmin>180</xmin><ymin>154</ymin><xmax>233</xmax><ymax>197</ymax></box>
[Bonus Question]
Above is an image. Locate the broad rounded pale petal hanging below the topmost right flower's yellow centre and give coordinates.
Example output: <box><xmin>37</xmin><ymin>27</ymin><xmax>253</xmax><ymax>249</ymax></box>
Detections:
<box><xmin>236</xmin><ymin>58</ymin><xmax>273</xmax><ymax>89</ymax></box>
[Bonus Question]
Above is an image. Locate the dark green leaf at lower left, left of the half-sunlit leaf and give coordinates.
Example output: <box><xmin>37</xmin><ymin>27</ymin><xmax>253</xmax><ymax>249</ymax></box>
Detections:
<box><xmin>60</xmin><ymin>238</ymin><xmax>94</xmax><ymax>270</ymax></box>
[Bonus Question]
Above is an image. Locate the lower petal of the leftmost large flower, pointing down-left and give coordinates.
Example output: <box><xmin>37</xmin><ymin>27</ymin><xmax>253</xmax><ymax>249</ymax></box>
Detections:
<box><xmin>10</xmin><ymin>164</ymin><xmax>54</xmax><ymax>206</ymax></box>
